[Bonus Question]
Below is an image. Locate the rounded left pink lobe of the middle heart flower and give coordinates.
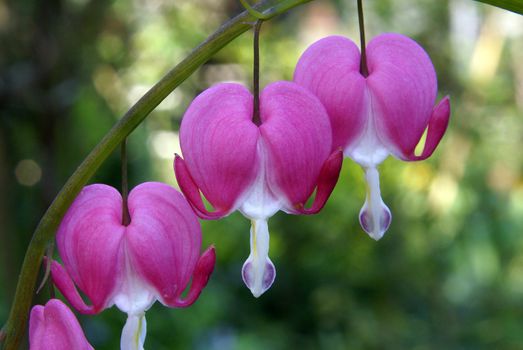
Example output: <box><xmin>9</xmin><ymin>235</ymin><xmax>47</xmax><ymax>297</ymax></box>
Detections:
<box><xmin>176</xmin><ymin>84</ymin><xmax>259</xmax><ymax>213</ymax></box>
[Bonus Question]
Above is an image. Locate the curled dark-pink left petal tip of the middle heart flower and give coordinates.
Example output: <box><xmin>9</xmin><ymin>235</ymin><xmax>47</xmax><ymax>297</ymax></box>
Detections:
<box><xmin>174</xmin><ymin>155</ymin><xmax>230</xmax><ymax>220</ymax></box>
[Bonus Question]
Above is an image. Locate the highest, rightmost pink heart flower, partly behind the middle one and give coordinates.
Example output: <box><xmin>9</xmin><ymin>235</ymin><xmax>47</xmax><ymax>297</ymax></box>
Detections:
<box><xmin>294</xmin><ymin>34</ymin><xmax>450</xmax><ymax>240</ymax></box>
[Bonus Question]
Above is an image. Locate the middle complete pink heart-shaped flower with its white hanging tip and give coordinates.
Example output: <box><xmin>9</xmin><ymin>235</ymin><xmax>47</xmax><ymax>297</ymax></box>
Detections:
<box><xmin>175</xmin><ymin>82</ymin><xmax>343</xmax><ymax>297</ymax></box>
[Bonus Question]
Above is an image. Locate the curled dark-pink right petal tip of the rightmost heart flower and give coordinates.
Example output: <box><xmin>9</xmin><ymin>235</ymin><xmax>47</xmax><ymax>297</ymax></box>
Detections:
<box><xmin>402</xmin><ymin>96</ymin><xmax>450</xmax><ymax>160</ymax></box>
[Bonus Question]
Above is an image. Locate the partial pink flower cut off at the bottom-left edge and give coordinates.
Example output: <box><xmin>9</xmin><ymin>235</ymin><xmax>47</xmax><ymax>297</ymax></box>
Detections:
<box><xmin>29</xmin><ymin>299</ymin><xmax>93</xmax><ymax>350</ymax></box>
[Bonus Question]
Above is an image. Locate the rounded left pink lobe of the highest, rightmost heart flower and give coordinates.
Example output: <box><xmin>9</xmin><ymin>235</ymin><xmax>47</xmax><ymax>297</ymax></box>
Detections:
<box><xmin>294</xmin><ymin>36</ymin><xmax>366</xmax><ymax>150</ymax></box>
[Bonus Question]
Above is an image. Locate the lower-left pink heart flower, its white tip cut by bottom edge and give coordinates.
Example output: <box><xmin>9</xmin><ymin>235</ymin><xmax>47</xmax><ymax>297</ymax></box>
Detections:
<box><xmin>51</xmin><ymin>182</ymin><xmax>216</xmax><ymax>349</ymax></box>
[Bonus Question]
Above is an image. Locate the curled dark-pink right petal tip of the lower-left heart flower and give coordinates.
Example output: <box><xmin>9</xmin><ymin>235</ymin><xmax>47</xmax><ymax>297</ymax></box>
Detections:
<box><xmin>168</xmin><ymin>246</ymin><xmax>216</xmax><ymax>308</ymax></box>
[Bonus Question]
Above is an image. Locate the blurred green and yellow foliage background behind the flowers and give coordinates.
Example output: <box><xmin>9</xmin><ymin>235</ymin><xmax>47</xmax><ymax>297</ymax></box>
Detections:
<box><xmin>0</xmin><ymin>0</ymin><xmax>523</xmax><ymax>350</ymax></box>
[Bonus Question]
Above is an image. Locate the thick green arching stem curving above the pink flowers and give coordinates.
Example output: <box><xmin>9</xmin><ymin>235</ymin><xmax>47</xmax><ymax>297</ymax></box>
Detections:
<box><xmin>2</xmin><ymin>0</ymin><xmax>312</xmax><ymax>350</ymax></box>
